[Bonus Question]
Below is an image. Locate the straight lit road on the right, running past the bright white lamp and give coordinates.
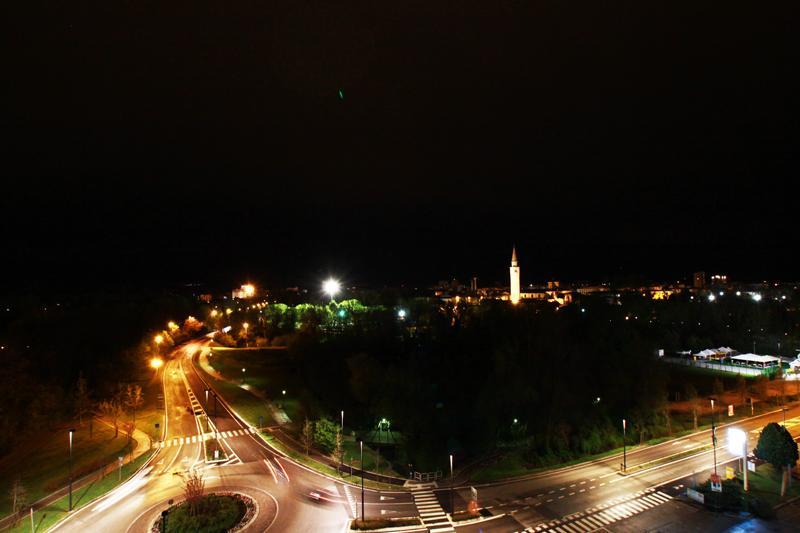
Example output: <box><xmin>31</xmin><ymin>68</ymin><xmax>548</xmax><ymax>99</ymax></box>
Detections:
<box><xmin>446</xmin><ymin>407</ymin><xmax>800</xmax><ymax>532</ymax></box>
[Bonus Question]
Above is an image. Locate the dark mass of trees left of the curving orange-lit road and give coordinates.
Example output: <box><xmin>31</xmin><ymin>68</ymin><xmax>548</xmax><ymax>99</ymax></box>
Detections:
<box><xmin>0</xmin><ymin>291</ymin><xmax>194</xmax><ymax>454</ymax></box>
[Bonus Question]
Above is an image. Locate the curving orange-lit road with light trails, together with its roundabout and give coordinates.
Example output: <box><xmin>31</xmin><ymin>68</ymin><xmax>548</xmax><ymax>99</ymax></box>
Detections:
<box><xmin>49</xmin><ymin>341</ymin><xmax>415</xmax><ymax>533</ymax></box>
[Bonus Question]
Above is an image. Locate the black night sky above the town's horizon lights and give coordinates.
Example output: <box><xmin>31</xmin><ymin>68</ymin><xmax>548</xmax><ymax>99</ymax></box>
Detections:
<box><xmin>0</xmin><ymin>0</ymin><xmax>800</xmax><ymax>285</ymax></box>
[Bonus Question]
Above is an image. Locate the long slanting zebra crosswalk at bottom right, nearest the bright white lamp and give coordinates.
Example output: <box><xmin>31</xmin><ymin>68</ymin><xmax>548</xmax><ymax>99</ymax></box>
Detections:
<box><xmin>524</xmin><ymin>489</ymin><xmax>672</xmax><ymax>533</ymax></box>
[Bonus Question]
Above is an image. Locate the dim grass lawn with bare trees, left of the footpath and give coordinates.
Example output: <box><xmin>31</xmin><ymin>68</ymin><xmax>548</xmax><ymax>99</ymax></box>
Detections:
<box><xmin>0</xmin><ymin>420</ymin><xmax>134</xmax><ymax>516</ymax></box>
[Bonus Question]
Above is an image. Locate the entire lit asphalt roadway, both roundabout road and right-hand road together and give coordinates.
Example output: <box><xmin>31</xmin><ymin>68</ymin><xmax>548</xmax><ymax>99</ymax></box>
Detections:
<box><xmin>50</xmin><ymin>340</ymin><xmax>800</xmax><ymax>533</ymax></box>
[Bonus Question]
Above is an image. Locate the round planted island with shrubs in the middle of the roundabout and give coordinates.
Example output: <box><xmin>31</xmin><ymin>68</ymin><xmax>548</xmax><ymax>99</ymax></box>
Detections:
<box><xmin>150</xmin><ymin>492</ymin><xmax>258</xmax><ymax>533</ymax></box>
